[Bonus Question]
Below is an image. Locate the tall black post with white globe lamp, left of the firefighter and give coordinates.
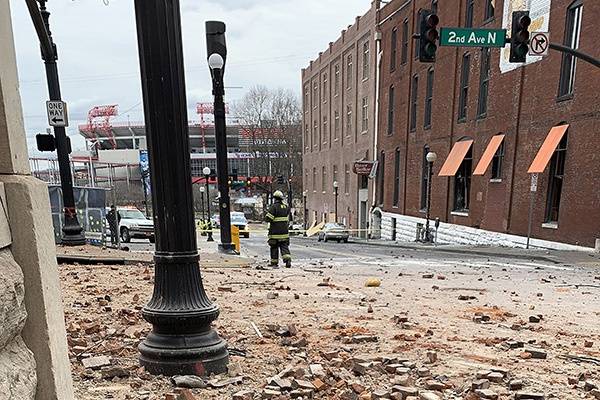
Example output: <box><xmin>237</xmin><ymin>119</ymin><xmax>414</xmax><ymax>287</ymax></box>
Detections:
<box><xmin>206</xmin><ymin>21</ymin><xmax>235</xmax><ymax>254</ymax></box>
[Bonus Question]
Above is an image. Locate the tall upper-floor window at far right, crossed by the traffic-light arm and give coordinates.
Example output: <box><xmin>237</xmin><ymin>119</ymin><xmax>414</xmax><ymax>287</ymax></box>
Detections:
<box><xmin>558</xmin><ymin>0</ymin><xmax>583</xmax><ymax>98</ymax></box>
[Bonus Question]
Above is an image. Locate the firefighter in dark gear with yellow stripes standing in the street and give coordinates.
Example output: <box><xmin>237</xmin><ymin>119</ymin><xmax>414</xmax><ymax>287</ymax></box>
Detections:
<box><xmin>265</xmin><ymin>190</ymin><xmax>292</xmax><ymax>268</ymax></box>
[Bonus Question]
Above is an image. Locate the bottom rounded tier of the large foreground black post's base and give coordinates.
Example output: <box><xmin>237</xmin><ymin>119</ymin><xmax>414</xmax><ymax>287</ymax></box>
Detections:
<box><xmin>138</xmin><ymin>328</ymin><xmax>229</xmax><ymax>376</ymax></box>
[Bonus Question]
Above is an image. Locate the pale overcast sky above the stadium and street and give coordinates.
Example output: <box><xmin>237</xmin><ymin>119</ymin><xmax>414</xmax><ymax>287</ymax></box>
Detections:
<box><xmin>10</xmin><ymin>0</ymin><xmax>370</xmax><ymax>154</ymax></box>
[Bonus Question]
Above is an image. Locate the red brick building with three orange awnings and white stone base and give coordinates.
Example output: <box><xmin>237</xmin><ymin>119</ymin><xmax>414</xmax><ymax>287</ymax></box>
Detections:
<box><xmin>378</xmin><ymin>0</ymin><xmax>600</xmax><ymax>246</ymax></box>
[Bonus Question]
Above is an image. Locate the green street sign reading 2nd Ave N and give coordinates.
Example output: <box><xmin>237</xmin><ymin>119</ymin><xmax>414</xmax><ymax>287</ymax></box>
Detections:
<box><xmin>440</xmin><ymin>28</ymin><xmax>506</xmax><ymax>47</ymax></box>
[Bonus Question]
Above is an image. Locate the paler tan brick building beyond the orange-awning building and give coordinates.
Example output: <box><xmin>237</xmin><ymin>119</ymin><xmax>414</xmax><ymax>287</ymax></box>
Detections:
<box><xmin>302</xmin><ymin>0</ymin><xmax>379</xmax><ymax>235</ymax></box>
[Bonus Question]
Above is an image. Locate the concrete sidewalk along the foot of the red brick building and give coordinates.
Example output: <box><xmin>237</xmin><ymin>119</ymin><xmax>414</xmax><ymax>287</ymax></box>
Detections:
<box><xmin>298</xmin><ymin>236</ymin><xmax>600</xmax><ymax>267</ymax></box>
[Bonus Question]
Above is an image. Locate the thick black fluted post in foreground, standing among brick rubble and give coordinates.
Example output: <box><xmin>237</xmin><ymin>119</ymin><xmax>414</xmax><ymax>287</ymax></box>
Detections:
<box><xmin>135</xmin><ymin>0</ymin><xmax>229</xmax><ymax>376</ymax></box>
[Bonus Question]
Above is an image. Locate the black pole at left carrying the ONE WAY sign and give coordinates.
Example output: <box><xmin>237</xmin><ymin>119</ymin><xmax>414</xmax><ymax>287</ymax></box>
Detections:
<box><xmin>27</xmin><ymin>0</ymin><xmax>85</xmax><ymax>246</ymax></box>
